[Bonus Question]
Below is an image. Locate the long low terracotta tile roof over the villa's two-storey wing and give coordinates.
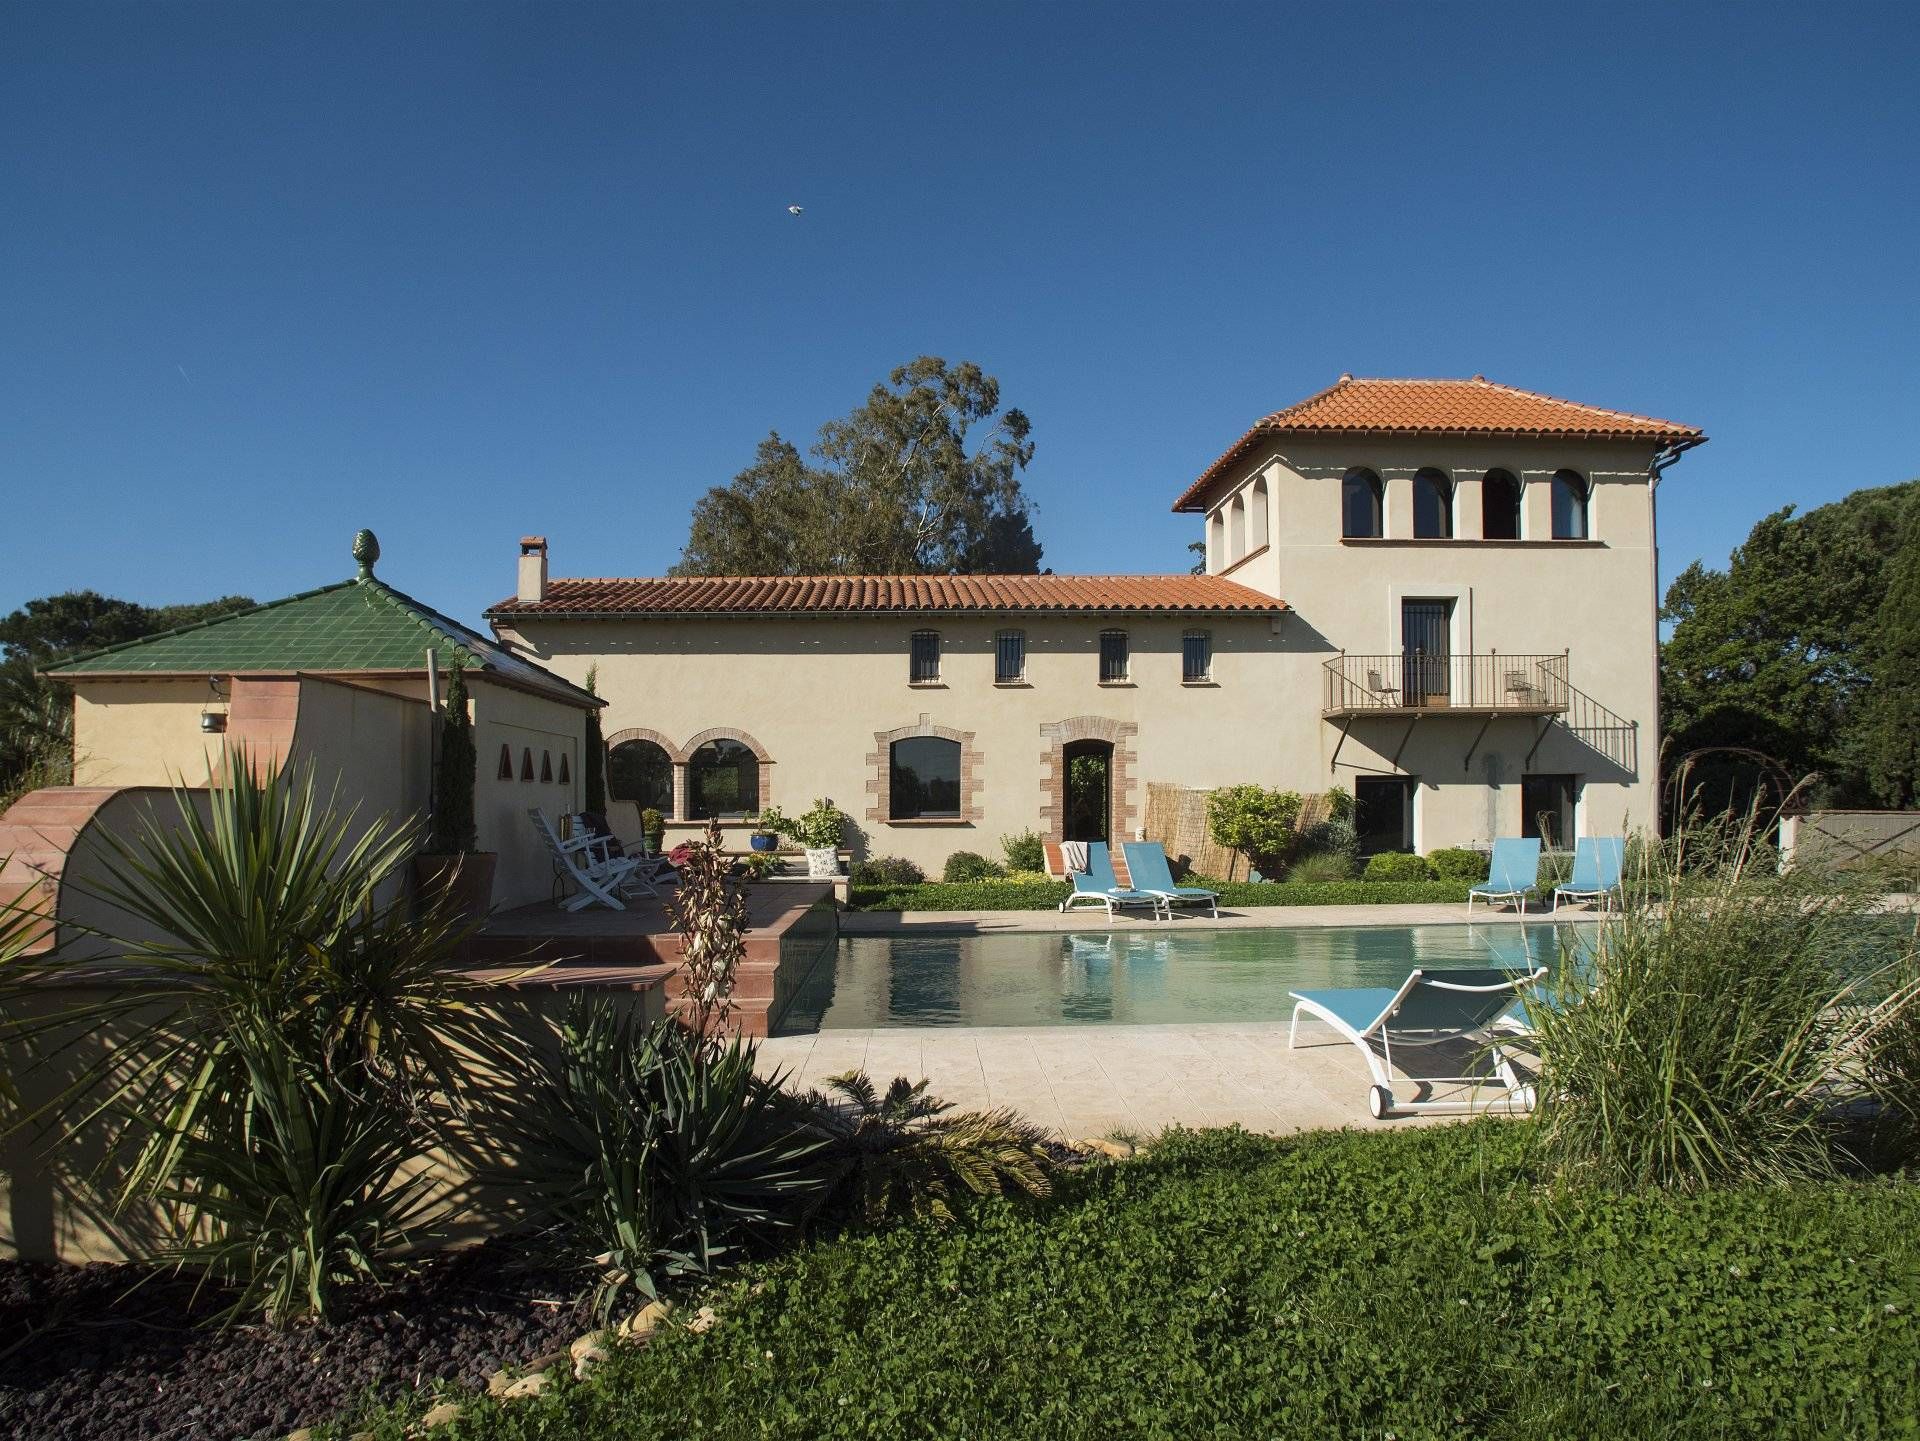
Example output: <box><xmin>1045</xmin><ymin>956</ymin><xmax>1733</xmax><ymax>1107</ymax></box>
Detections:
<box><xmin>486</xmin><ymin>576</ymin><xmax>1286</xmax><ymax>622</ymax></box>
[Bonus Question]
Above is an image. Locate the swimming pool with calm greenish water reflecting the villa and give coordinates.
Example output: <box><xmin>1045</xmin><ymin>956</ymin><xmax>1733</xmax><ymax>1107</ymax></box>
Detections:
<box><xmin>776</xmin><ymin>923</ymin><xmax>1592</xmax><ymax>1034</ymax></box>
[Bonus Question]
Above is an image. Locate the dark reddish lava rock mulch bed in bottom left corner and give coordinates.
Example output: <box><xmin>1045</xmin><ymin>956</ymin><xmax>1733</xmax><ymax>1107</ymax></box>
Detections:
<box><xmin>0</xmin><ymin>1241</ymin><xmax>591</xmax><ymax>1441</ymax></box>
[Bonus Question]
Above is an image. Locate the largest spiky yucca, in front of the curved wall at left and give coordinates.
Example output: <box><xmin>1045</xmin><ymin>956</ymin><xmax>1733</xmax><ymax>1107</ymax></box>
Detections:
<box><xmin>19</xmin><ymin>752</ymin><xmax>518</xmax><ymax>1322</ymax></box>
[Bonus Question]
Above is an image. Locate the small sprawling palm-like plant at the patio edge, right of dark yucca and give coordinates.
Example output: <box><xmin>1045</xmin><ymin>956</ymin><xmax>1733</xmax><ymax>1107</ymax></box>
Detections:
<box><xmin>803</xmin><ymin>1071</ymin><xmax>1052</xmax><ymax>1224</ymax></box>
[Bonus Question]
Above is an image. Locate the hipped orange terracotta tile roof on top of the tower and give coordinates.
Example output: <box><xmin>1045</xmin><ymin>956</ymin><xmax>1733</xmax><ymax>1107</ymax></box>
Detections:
<box><xmin>1173</xmin><ymin>376</ymin><xmax>1707</xmax><ymax>510</ymax></box>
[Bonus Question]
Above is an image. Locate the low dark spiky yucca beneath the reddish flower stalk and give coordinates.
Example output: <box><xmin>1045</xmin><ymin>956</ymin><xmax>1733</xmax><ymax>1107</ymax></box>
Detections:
<box><xmin>493</xmin><ymin>998</ymin><xmax>829</xmax><ymax>1314</ymax></box>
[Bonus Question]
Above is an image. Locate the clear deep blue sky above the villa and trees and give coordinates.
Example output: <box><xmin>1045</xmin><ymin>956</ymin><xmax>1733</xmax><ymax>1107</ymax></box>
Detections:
<box><xmin>0</xmin><ymin>0</ymin><xmax>1920</xmax><ymax>620</ymax></box>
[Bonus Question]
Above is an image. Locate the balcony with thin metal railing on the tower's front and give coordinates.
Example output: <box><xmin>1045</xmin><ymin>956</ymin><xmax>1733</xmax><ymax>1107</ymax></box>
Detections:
<box><xmin>1321</xmin><ymin>650</ymin><xmax>1574</xmax><ymax>720</ymax></box>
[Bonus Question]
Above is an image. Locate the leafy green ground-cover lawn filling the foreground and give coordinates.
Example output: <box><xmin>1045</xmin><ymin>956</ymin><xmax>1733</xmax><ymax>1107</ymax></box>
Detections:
<box><xmin>337</xmin><ymin>1121</ymin><xmax>1920</xmax><ymax>1441</ymax></box>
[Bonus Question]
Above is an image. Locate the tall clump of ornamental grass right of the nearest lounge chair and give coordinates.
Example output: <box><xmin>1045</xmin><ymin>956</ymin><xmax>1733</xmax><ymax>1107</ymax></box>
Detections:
<box><xmin>1534</xmin><ymin>794</ymin><xmax>1887</xmax><ymax>1190</ymax></box>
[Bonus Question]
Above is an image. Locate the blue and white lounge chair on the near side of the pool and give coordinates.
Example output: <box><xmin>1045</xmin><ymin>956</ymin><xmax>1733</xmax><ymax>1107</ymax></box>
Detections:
<box><xmin>1286</xmin><ymin>965</ymin><xmax>1548</xmax><ymax>1121</ymax></box>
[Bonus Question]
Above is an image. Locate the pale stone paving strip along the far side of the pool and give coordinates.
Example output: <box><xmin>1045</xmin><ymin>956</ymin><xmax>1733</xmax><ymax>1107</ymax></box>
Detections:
<box><xmin>839</xmin><ymin>904</ymin><xmax>1601</xmax><ymax>936</ymax></box>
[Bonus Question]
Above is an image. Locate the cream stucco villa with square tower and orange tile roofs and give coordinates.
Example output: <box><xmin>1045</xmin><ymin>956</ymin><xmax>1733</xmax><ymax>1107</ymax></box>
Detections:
<box><xmin>486</xmin><ymin>376</ymin><xmax>1705</xmax><ymax>867</ymax></box>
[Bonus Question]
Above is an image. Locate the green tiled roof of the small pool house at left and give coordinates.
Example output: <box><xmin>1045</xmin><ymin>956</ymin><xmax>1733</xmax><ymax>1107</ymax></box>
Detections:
<box><xmin>46</xmin><ymin>574</ymin><xmax>599</xmax><ymax>704</ymax></box>
